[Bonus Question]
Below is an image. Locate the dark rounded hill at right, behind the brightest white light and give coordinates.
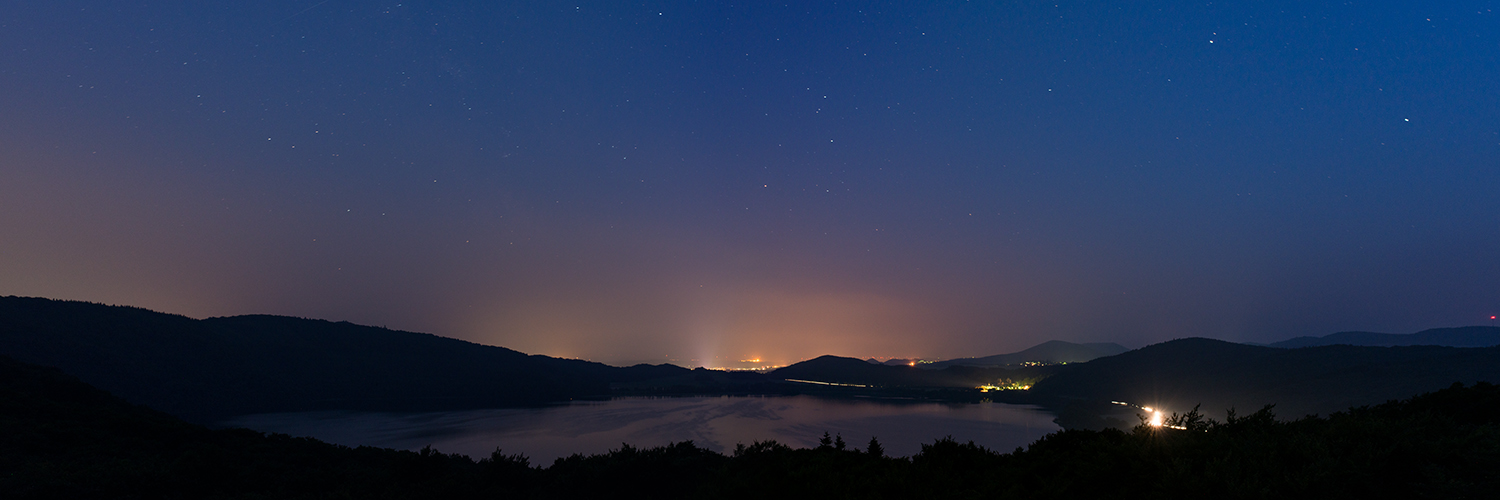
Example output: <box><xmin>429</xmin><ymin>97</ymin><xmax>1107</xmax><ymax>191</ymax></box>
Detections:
<box><xmin>1032</xmin><ymin>338</ymin><xmax>1500</xmax><ymax>417</ymax></box>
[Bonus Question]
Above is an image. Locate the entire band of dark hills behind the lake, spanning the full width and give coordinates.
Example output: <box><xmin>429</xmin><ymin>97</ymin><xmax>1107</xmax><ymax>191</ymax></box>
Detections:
<box><xmin>0</xmin><ymin>297</ymin><xmax>1500</xmax><ymax>428</ymax></box>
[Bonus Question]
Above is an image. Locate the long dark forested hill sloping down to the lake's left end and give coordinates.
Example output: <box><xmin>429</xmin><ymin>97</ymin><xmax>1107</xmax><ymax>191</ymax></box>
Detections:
<box><xmin>0</xmin><ymin>297</ymin><xmax>689</xmax><ymax>422</ymax></box>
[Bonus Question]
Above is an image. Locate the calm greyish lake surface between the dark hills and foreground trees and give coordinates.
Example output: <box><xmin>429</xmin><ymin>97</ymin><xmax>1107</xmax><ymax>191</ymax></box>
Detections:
<box><xmin>224</xmin><ymin>396</ymin><xmax>1059</xmax><ymax>465</ymax></box>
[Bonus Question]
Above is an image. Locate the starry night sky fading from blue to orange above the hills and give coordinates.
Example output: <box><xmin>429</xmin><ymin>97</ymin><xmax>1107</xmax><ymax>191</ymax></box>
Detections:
<box><xmin>0</xmin><ymin>0</ymin><xmax>1500</xmax><ymax>366</ymax></box>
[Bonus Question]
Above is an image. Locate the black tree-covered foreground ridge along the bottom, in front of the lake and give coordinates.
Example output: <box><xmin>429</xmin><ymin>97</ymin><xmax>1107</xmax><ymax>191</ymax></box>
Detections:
<box><xmin>0</xmin><ymin>352</ymin><xmax>1500</xmax><ymax>498</ymax></box>
